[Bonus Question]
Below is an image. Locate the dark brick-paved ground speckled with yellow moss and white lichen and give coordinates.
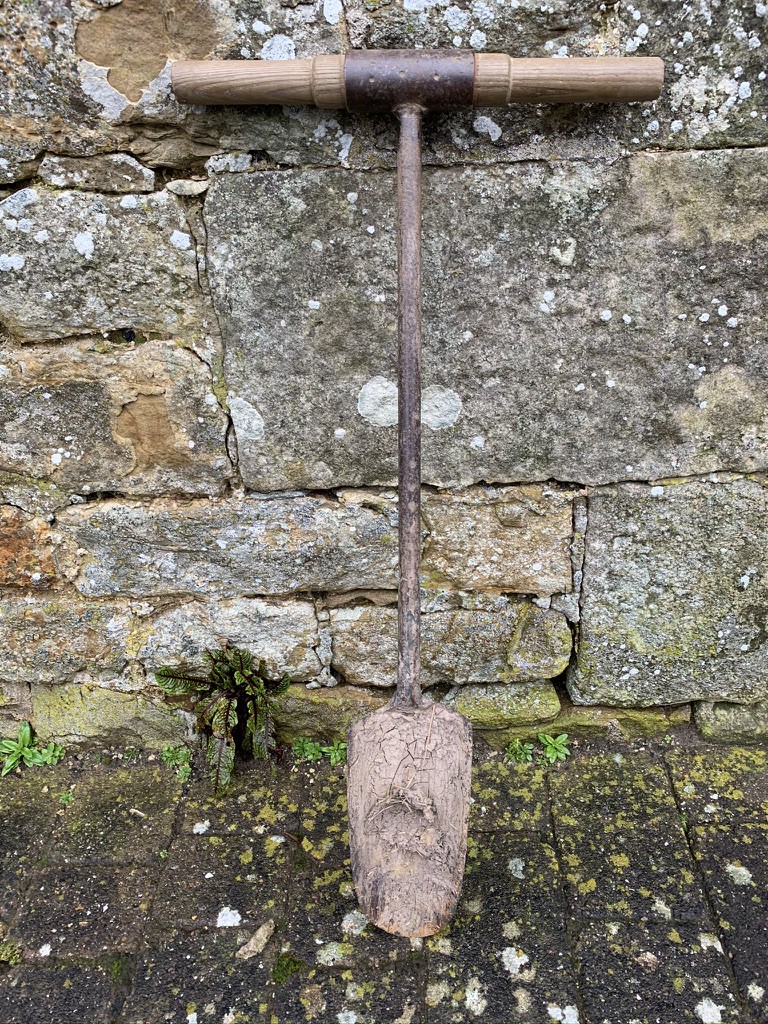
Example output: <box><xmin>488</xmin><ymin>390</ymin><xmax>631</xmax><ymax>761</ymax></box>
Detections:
<box><xmin>0</xmin><ymin>740</ymin><xmax>768</xmax><ymax>1024</ymax></box>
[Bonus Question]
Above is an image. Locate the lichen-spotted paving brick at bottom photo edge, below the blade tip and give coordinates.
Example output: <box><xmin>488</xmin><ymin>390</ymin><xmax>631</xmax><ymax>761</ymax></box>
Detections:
<box><xmin>264</xmin><ymin>950</ymin><xmax>431</xmax><ymax>1024</ymax></box>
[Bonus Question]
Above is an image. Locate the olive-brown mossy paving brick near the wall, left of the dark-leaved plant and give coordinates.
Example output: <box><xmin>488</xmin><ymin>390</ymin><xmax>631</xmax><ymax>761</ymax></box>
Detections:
<box><xmin>48</xmin><ymin>763</ymin><xmax>182</xmax><ymax>864</ymax></box>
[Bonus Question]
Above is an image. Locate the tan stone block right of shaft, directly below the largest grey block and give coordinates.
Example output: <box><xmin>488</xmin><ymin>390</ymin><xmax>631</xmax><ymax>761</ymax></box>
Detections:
<box><xmin>423</xmin><ymin>486</ymin><xmax>572</xmax><ymax>594</ymax></box>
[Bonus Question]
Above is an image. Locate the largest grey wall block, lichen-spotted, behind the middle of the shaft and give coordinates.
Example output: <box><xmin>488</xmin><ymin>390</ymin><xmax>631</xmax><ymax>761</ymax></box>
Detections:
<box><xmin>206</xmin><ymin>150</ymin><xmax>768</xmax><ymax>490</ymax></box>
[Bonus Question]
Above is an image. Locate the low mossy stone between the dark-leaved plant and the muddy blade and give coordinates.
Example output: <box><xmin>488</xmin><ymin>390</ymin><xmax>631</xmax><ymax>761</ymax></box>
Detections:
<box><xmin>275</xmin><ymin>684</ymin><xmax>390</xmax><ymax>743</ymax></box>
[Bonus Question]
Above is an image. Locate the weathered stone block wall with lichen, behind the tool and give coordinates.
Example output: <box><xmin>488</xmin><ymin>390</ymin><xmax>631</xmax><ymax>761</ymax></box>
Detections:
<box><xmin>0</xmin><ymin>0</ymin><xmax>768</xmax><ymax>746</ymax></box>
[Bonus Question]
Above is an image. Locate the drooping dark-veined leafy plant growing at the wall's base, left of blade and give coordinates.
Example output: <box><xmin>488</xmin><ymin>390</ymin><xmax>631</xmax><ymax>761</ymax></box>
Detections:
<box><xmin>155</xmin><ymin>644</ymin><xmax>291</xmax><ymax>796</ymax></box>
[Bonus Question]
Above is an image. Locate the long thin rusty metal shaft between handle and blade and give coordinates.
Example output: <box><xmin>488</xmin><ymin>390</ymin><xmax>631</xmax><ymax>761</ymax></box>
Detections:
<box><xmin>394</xmin><ymin>103</ymin><xmax>422</xmax><ymax>708</ymax></box>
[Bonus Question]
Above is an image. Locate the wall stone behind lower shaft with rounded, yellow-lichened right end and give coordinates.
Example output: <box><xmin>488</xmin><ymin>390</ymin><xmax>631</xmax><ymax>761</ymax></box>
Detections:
<box><xmin>330</xmin><ymin>599</ymin><xmax>571</xmax><ymax>687</ymax></box>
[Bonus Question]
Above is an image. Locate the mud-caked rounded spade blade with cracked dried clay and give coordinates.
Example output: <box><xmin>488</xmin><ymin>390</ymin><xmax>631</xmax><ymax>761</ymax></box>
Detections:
<box><xmin>347</xmin><ymin>703</ymin><xmax>472</xmax><ymax>938</ymax></box>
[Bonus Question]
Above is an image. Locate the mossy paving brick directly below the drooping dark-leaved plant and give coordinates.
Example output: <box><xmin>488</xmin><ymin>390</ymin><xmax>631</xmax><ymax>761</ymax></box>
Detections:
<box><xmin>181</xmin><ymin>761</ymin><xmax>299</xmax><ymax>836</ymax></box>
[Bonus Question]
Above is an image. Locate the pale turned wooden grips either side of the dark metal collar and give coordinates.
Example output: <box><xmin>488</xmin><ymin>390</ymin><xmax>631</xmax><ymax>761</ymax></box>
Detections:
<box><xmin>171</xmin><ymin>50</ymin><xmax>664</xmax><ymax>110</ymax></box>
